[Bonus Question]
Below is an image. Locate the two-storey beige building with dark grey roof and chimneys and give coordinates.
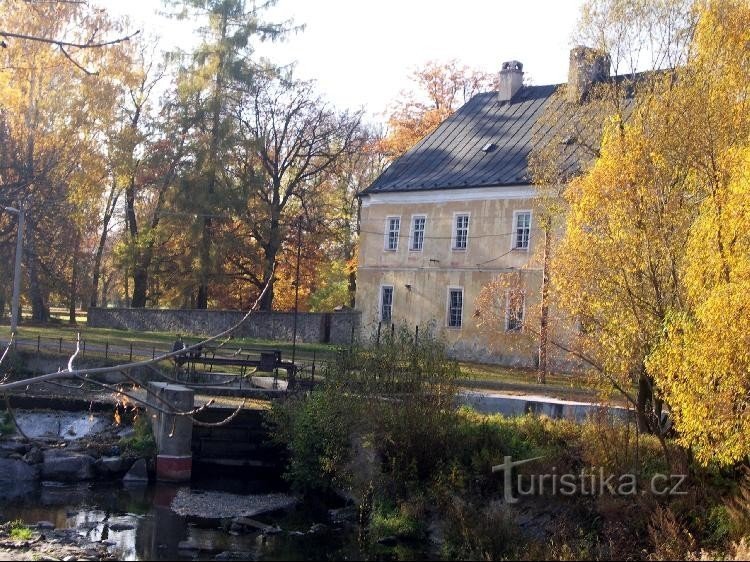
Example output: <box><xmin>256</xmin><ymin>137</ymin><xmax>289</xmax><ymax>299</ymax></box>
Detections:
<box><xmin>356</xmin><ymin>47</ymin><xmax>617</xmax><ymax>368</ymax></box>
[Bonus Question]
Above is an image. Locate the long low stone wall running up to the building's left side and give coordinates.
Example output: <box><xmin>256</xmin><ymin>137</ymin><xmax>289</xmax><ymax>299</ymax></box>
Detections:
<box><xmin>87</xmin><ymin>308</ymin><xmax>360</xmax><ymax>344</ymax></box>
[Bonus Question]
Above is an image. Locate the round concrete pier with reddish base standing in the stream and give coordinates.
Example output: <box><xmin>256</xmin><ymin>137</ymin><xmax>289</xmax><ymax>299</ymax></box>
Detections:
<box><xmin>147</xmin><ymin>382</ymin><xmax>194</xmax><ymax>482</ymax></box>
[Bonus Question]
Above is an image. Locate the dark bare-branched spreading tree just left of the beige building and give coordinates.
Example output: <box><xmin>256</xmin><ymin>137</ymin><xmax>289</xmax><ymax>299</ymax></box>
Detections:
<box><xmin>229</xmin><ymin>76</ymin><xmax>361</xmax><ymax>310</ymax></box>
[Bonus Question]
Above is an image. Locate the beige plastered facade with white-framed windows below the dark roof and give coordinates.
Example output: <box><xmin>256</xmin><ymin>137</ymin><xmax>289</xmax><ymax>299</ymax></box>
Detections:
<box><xmin>357</xmin><ymin>185</ymin><xmax>560</xmax><ymax>368</ymax></box>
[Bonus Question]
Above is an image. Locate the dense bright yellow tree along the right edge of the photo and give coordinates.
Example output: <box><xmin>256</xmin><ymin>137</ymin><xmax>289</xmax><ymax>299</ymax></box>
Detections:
<box><xmin>647</xmin><ymin>1</ymin><xmax>750</xmax><ymax>464</ymax></box>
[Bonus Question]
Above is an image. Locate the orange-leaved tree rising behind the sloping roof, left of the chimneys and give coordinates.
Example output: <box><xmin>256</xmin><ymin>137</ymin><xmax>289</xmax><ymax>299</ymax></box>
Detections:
<box><xmin>381</xmin><ymin>60</ymin><xmax>494</xmax><ymax>160</ymax></box>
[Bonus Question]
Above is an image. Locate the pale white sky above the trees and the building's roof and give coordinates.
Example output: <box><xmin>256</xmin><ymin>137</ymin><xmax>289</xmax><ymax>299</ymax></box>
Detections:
<box><xmin>98</xmin><ymin>0</ymin><xmax>582</xmax><ymax>122</ymax></box>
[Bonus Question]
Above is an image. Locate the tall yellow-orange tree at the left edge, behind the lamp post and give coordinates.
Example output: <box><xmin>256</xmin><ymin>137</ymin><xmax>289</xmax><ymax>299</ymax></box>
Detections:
<box><xmin>0</xmin><ymin>2</ymin><xmax>128</xmax><ymax>321</ymax></box>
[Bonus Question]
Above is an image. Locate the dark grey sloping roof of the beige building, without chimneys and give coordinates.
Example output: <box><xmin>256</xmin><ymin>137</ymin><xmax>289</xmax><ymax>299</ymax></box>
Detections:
<box><xmin>363</xmin><ymin>85</ymin><xmax>591</xmax><ymax>195</ymax></box>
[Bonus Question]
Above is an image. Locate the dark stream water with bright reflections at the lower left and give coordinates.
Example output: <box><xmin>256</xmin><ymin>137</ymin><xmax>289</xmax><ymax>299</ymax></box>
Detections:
<box><xmin>0</xmin><ymin>479</ymin><xmax>428</xmax><ymax>560</ymax></box>
